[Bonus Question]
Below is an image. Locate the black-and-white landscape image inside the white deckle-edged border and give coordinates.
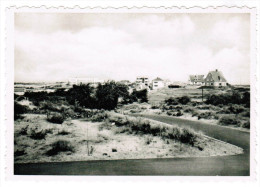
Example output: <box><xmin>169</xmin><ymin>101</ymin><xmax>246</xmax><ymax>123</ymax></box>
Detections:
<box><xmin>13</xmin><ymin>11</ymin><xmax>254</xmax><ymax>176</ymax></box>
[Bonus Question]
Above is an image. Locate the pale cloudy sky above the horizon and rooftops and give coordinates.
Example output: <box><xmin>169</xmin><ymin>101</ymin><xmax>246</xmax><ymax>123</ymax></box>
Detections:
<box><xmin>14</xmin><ymin>13</ymin><xmax>250</xmax><ymax>84</ymax></box>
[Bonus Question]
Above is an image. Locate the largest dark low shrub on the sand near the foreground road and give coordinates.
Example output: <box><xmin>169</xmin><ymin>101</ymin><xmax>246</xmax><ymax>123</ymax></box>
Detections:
<box><xmin>46</xmin><ymin>140</ymin><xmax>75</xmax><ymax>156</ymax></box>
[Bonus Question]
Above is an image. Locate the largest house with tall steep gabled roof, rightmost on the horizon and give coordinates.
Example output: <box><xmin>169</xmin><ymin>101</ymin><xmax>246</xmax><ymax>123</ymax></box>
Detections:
<box><xmin>205</xmin><ymin>69</ymin><xmax>227</xmax><ymax>87</ymax></box>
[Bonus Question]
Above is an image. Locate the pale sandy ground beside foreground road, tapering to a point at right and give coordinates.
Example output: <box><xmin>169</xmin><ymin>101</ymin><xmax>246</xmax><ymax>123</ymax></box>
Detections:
<box><xmin>14</xmin><ymin>114</ymin><xmax>243</xmax><ymax>163</ymax></box>
